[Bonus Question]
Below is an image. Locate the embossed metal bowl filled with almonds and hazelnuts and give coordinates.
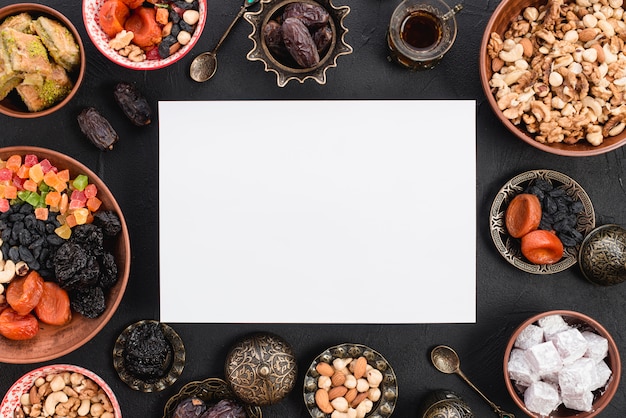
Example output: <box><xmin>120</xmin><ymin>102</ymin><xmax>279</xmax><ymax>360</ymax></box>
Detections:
<box><xmin>304</xmin><ymin>343</ymin><xmax>398</xmax><ymax>418</ymax></box>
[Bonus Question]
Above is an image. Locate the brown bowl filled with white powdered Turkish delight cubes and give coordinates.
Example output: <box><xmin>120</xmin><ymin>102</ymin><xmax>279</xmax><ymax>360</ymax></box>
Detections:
<box><xmin>503</xmin><ymin>310</ymin><xmax>622</xmax><ymax>418</ymax></box>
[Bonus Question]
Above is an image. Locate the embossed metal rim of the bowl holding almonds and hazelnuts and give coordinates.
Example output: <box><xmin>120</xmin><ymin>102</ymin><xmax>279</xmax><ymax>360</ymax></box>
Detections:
<box><xmin>303</xmin><ymin>343</ymin><xmax>398</xmax><ymax>418</ymax></box>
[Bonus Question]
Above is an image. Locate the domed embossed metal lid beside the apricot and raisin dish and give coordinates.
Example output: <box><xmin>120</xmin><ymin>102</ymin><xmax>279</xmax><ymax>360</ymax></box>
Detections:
<box><xmin>578</xmin><ymin>224</ymin><xmax>626</xmax><ymax>286</ymax></box>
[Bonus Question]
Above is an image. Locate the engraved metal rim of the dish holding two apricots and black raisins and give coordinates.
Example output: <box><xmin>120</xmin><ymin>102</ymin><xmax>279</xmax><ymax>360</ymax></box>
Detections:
<box><xmin>489</xmin><ymin>170</ymin><xmax>596</xmax><ymax>274</ymax></box>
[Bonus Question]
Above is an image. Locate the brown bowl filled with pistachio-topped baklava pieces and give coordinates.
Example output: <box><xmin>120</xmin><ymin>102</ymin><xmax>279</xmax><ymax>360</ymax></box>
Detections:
<box><xmin>0</xmin><ymin>3</ymin><xmax>86</xmax><ymax>119</ymax></box>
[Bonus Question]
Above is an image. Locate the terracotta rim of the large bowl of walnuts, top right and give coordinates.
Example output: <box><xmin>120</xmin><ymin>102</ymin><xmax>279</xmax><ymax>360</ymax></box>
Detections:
<box><xmin>479</xmin><ymin>0</ymin><xmax>626</xmax><ymax>157</ymax></box>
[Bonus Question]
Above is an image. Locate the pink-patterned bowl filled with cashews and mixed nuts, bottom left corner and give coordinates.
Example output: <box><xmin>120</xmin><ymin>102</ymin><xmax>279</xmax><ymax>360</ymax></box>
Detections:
<box><xmin>0</xmin><ymin>364</ymin><xmax>122</xmax><ymax>418</ymax></box>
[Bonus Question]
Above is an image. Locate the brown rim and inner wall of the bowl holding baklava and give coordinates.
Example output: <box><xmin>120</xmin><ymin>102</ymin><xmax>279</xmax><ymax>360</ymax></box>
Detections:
<box><xmin>0</xmin><ymin>3</ymin><xmax>86</xmax><ymax>118</ymax></box>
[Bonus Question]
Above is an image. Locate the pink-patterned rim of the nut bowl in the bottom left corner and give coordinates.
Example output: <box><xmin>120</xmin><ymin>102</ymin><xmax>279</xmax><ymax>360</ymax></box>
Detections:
<box><xmin>0</xmin><ymin>364</ymin><xmax>122</xmax><ymax>418</ymax></box>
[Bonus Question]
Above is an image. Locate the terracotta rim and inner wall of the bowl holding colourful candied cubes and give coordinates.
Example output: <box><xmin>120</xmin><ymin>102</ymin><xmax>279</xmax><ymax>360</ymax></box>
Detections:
<box><xmin>0</xmin><ymin>146</ymin><xmax>131</xmax><ymax>364</ymax></box>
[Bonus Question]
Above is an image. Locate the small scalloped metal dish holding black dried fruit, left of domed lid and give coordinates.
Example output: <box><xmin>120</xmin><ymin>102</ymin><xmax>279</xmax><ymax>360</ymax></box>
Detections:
<box><xmin>113</xmin><ymin>320</ymin><xmax>185</xmax><ymax>392</ymax></box>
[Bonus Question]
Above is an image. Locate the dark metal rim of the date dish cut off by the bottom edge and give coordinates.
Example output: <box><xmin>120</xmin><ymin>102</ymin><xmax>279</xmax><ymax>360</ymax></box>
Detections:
<box><xmin>163</xmin><ymin>377</ymin><xmax>263</xmax><ymax>418</ymax></box>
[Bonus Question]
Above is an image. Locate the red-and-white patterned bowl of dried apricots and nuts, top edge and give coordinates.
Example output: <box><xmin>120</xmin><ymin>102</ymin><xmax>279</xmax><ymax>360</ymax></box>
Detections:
<box><xmin>83</xmin><ymin>0</ymin><xmax>207</xmax><ymax>70</ymax></box>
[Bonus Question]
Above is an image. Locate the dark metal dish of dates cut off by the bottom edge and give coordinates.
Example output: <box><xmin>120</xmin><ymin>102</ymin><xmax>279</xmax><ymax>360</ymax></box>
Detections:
<box><xmin>163</xmin><ymin>377</ymin><xmax>263</xmax><ymax>418</ymax></box>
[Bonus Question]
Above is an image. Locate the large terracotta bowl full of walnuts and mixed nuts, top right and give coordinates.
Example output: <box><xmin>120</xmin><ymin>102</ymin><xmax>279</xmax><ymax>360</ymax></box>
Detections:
<box><xmin>479</xmin><ymin>0</ymin><xmax>626</xmax><ymax>157</ymax></box>
